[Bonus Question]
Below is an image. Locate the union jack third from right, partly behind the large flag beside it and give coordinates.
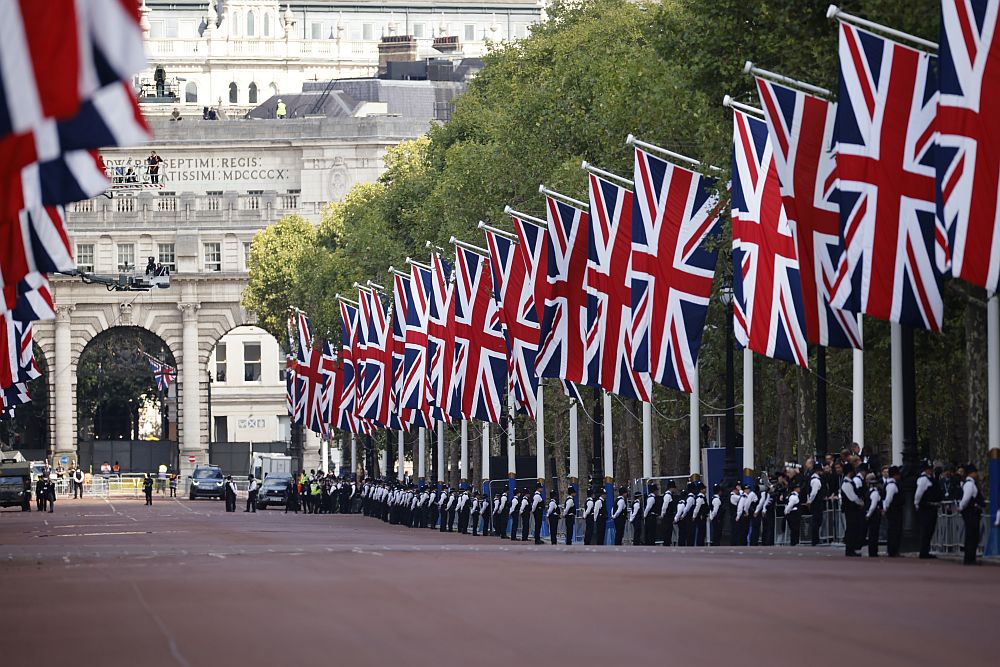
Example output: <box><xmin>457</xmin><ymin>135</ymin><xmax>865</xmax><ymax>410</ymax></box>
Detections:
<box><xmin>757</xmin><ymin>79</ymin><xmax>861</xmax><ymax>350</ymax></box>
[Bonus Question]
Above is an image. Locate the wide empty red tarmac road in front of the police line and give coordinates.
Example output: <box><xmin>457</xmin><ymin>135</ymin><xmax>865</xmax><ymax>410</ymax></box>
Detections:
<box><xmin>0</xmin><ymin>497</ymin><xmax>1000</xmax><ymax>667</ymax></box>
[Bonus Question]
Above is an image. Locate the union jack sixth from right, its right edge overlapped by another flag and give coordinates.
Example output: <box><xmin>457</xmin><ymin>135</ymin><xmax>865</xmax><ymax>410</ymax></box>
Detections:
<box><xmin>586</xmin><ymin>174</ymin><xmax>653</xmax><ymax>401</ymax></box>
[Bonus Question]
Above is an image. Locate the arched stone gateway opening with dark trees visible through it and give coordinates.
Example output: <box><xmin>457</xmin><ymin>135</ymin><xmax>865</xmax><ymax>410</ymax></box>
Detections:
<box><xmin>77</xmin><ymin>326</ymin><xmax>177</xmax><ymax>472</ymax></box>
